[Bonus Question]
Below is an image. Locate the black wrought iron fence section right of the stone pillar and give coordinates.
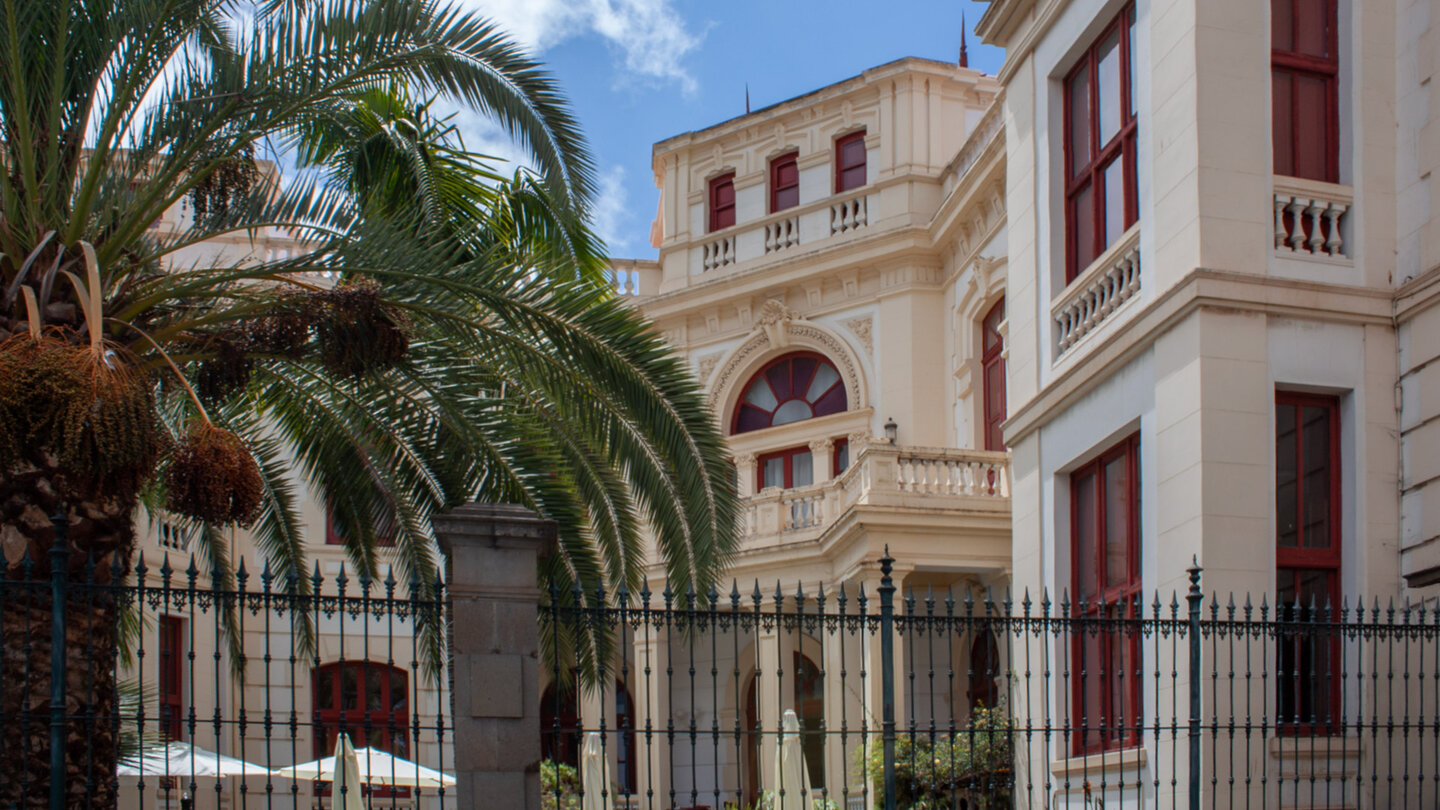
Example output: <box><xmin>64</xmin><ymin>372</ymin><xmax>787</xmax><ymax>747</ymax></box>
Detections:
<box><xmin>540</xmin><ymin>558</ymin><xmax>1440</xmax><ymax>810</ymax></box>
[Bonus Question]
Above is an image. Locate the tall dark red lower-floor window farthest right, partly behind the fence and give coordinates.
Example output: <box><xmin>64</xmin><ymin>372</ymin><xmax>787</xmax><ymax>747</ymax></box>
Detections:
<box><xmin>1274</xmin><ymin>391</ymin><xmax>1344</xmax><ymax>734</ymax></box>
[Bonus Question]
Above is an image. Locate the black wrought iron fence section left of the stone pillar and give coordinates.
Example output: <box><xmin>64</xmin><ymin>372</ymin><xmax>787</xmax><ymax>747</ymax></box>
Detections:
<box><xmin>0</xmin><ymin>519</ymin><xmax>455</xmax><ymax>810</ymax></box>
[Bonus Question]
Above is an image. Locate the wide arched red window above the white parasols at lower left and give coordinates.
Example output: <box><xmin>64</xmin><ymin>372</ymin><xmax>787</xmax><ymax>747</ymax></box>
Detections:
<box><xmin>311</xmin><ymin>660</ymin><xmax>415</xmax><ymax>798</ymax></box>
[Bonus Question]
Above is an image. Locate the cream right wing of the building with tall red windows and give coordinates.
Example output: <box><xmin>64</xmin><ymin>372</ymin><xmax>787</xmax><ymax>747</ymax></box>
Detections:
<box><xmin>976</xmin><ymin>0</ymin><xmax>1440</xmax><ymax>807</ymax></box>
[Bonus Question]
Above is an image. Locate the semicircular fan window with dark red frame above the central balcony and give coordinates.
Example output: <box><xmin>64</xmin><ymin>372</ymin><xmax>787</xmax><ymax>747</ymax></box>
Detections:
<box><xmin>732</xmin><ymin>352</ymin><xmax>848</xmax><ymax>434</ymax></box>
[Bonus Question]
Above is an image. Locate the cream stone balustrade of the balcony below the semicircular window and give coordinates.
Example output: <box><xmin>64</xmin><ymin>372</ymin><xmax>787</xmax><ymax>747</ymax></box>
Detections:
<box><xmin>740</xmin><ymin>444</ymin><xmax>1009</xmax><ymax>542</ymax></box>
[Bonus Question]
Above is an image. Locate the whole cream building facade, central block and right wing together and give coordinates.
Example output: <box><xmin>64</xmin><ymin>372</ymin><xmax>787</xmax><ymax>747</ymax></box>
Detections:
<box><xmin>112</xmin><ymin>0</ymin><xmax>1440</xmax><ymax>810</ymax></box>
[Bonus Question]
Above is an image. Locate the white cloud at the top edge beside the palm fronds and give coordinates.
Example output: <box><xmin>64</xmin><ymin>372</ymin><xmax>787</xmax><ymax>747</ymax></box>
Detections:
<box><xmin>464</xmin><ymin>0</ymin><xmax>700</xmax><ymax>92</ymax></box>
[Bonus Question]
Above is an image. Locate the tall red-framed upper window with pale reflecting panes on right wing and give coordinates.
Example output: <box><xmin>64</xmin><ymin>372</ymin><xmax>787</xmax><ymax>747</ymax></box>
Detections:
<box><xmin>1064</xmin><ymin>6</ymin><xmax>1139</xmax><ymax>282</ymax></box>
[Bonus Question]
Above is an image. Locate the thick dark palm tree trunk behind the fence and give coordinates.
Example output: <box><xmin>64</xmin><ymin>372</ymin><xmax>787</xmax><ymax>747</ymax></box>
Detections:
<box><xmin>0</xmin><ymin>458</ymin><xmax>135</xmax><ymax>810</ymax></box>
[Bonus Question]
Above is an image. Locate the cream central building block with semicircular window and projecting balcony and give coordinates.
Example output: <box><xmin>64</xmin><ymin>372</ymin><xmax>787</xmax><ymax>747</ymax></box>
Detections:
<box><xmin>580</xmin><ymin>59</ymin><xmax>1011</xmax><ymax>807</ymax></box>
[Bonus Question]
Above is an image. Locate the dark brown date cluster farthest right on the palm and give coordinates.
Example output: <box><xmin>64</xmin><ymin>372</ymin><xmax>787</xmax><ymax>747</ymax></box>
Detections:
<box><xmin>315</xmin><ymin>280</ymin><xmax>410</xmax><ymax>376</ymax></box>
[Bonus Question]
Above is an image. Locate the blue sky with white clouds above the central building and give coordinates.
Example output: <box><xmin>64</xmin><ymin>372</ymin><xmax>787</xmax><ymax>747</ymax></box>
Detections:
<box><xmin>461</xmin><ymin>0</ymin><xmax>1002</xmax><ymax>258</ymax></box>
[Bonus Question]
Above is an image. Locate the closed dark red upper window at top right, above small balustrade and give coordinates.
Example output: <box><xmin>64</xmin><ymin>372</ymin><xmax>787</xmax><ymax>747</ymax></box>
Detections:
<box><xmin>1270</xmin><ymin>0</ymin><xmax>1341</xmax><ymax>183</ymax></box>
